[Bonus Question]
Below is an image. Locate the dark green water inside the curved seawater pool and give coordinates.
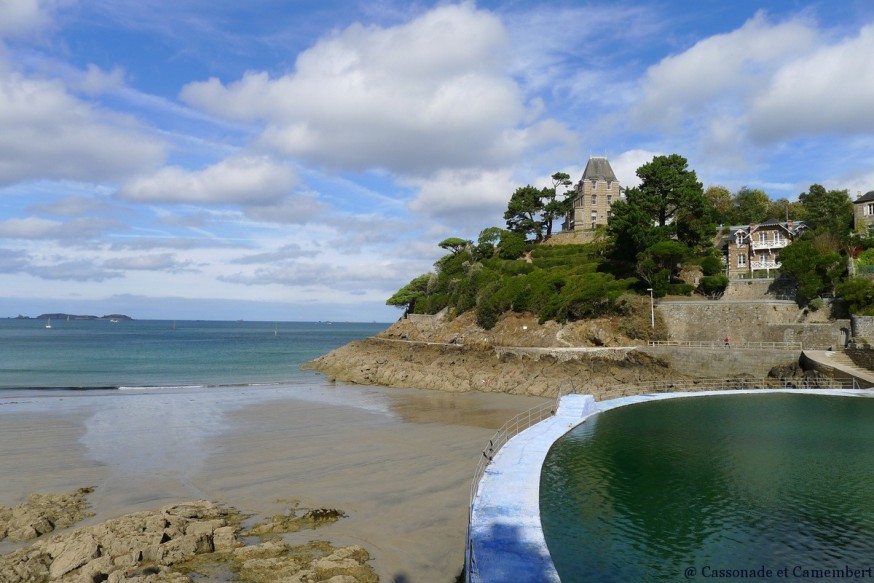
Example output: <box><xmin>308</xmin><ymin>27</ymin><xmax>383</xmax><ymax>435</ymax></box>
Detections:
<box><xmin>540</xmin><ymin>394</ymin><xmax>874</xmax><ymax>583</ymax></box>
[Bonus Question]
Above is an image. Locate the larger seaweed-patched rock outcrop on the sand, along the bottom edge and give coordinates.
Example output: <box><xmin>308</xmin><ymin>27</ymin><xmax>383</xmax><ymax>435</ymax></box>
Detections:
<box><xmin>0</xmin><ymin>492</ymin><xmax>377</xmax><ymax>583</ymax></box>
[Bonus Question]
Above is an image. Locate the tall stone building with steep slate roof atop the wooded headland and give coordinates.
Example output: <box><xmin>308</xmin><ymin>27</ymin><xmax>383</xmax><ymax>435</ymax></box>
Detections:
<box><xmin>562</xmin><ymin>156</ymin><xmax>624</xmax><ymax>231</ymax></box>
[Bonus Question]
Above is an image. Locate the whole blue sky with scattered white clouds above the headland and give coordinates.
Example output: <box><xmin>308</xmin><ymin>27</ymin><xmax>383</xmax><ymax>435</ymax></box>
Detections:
<box><xmin>0</xmin><ymin>0</ymin><xmax>874</xmax><ymax>322</ymax></box>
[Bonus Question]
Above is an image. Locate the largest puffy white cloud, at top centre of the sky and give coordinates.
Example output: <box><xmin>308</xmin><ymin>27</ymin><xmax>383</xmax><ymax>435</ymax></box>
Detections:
<box><xmin>181</xmin><ymin>4</ymin><xmax>568</xmax><ymax>174</ymax></box>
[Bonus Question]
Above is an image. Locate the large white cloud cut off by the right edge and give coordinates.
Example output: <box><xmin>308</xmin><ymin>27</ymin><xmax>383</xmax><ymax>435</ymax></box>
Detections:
<box><xmin>750</xmin><ymin>25</ymin><xmax>874</xmax><ymax>142</ymax></box>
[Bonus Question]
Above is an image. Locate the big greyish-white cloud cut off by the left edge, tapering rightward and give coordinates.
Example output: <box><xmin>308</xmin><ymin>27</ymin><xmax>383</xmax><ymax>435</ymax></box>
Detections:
<box><xmin>0</xmin><ymin>70</ymin><xmax>164</xmax><ymax>185</ymax></box>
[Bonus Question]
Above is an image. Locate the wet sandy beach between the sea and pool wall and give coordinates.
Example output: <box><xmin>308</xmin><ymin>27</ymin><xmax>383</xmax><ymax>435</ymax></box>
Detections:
<box><xmin>0</xmin><ymin>383</ymin><xmax>543</xmax><ymax>583</ymax></box>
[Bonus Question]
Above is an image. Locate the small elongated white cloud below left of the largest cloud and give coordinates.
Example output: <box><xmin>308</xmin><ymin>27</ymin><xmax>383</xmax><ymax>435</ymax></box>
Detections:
<box><xmin>118</xmin><ymin>156</ymin><xmax>295</xmax><ymax>205</ymax></box>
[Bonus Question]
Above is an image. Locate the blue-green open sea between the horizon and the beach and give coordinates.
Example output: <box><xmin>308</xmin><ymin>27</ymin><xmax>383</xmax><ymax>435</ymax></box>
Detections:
<box><xmin>0</xmin><ymin>319</ymin><xmax>388</xmax><ymax>391</ymax></box>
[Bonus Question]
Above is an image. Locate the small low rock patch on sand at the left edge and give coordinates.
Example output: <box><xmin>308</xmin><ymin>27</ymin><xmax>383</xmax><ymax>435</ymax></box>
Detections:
<box><xmin>0</xmin><ymin>488</ymin><xmax>93</xmax><ymax>541</ymax></box>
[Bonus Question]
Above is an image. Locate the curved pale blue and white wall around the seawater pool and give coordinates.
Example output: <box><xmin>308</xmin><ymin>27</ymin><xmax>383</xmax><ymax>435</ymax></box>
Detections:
<box><xmin>466</xmin><ymin>389</ymin><xmax>874</xmax><ymax>583</ymax></box>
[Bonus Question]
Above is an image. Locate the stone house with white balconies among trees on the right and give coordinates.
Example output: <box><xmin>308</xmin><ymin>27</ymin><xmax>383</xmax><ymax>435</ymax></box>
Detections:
<box><xmin>726</xmin><ymin>219</ymin><xmax>807</xmax><ymax>278</ymax></box>
